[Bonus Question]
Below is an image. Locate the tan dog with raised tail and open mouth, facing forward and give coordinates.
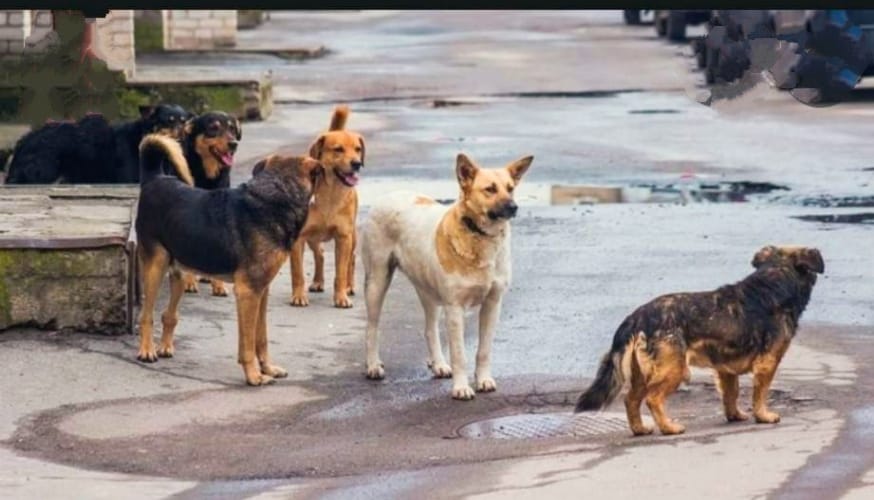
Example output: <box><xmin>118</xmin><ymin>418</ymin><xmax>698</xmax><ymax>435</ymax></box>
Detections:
<box><xmin>291</xmin><ymin>106</ymin><xmax>364</xmax><ymax>308</ymax></box>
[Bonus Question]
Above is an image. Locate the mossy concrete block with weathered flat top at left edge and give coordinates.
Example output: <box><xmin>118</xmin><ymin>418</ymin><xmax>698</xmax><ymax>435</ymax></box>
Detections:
<box><xmin>0</xmin><ymin>186</ymin><xmax>137</xmax><ymax>334</ymax></box>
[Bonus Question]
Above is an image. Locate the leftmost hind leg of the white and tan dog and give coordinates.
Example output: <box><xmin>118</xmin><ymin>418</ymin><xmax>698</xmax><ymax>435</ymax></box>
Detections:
<box><xmin>364</xmin><ymin>253</ymin><xmax>396</xmax><ymax>380</ymax></box>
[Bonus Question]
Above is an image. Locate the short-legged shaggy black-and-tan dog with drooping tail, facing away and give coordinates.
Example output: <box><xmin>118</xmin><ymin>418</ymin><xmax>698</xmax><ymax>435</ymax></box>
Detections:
<box><xmin>575</xmin><ymin>246</ymin><xmax>825</xmax><ymax>435</ymax></box>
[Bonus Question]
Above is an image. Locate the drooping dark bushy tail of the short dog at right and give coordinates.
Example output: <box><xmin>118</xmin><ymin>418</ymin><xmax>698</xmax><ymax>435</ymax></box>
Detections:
<box><xmin>574</xmin><ymin>318</ymin><xmax>643</xmax><ymax>413</ymax></box>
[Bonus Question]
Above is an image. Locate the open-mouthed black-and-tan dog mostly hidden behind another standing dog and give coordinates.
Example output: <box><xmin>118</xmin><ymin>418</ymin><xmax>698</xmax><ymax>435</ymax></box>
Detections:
<box><xmin>182</xmin><ymin>111</ymin><xmax>243</xmax><ymax>297</ymax></box>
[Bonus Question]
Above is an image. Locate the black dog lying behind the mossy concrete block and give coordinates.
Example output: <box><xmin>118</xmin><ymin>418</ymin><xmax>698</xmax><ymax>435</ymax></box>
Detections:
<box><xmin>6</xmin><ymin>104</ymin><xmax>193</xmax><ymax>184</ymax></box>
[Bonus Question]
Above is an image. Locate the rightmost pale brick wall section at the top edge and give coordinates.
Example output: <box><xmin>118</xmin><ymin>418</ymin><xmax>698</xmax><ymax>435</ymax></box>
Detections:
<box><xmin>162</xmin><ymin>10</ymin><xmax>237</xmax><ymax>50</ymax></box>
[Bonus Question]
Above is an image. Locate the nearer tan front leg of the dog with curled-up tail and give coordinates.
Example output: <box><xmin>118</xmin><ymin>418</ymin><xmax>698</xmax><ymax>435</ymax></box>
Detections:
<box><xmin>234</xmin><ymin>278</ymin><xmax>273</xmax><ymax>385</ymax></box>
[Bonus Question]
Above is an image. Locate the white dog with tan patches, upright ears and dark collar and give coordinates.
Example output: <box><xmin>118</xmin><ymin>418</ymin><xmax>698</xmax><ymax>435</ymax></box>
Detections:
<box><xmin>361</xmin><ymin>154</ymin><xmax>534</xmax><ymax>399</ymax></box>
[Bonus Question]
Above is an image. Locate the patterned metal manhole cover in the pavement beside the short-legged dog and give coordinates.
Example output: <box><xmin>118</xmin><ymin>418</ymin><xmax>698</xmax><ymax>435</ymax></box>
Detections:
<box><xmin>458</xmin><ymin>413</ymin><xmax>651</xmax><ymax>439</ymax></box>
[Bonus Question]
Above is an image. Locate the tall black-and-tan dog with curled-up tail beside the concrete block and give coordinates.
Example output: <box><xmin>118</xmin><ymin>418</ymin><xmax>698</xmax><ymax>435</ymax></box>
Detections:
<box><xmin>136</xmin><ymin>135</ymin><xmax>323</xmax><ymax>385</ymax></box>
